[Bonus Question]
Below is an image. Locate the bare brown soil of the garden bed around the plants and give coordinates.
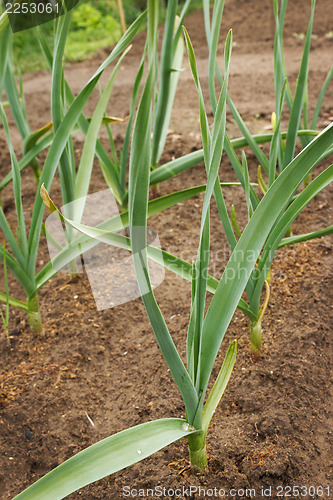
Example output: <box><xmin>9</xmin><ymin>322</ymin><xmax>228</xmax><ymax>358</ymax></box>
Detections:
<box><xmin>0</xmin><ymin>0</ymin><xmax>333</xmax><ymax>500</ymax></box>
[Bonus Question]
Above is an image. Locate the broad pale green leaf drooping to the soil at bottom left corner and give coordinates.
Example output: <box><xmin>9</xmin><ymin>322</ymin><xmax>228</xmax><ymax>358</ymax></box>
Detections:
<box><xmin>15</xmin><ymin>418</ymin><xmax>197</xmax><ymax>500</ymax></box>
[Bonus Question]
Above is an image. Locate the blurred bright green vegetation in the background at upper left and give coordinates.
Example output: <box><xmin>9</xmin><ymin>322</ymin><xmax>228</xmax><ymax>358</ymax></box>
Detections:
<box><xmin>9</xmin><ymin>0</ymin><xmax>202</xmax><ymax>73</ymax></box>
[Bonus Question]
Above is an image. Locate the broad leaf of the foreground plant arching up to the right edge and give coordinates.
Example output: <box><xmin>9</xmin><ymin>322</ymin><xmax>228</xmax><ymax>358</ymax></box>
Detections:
<box><xmin>200</xmin><ymin>124</ymin><xmax>333</xmax><ymax>404</ymax></box>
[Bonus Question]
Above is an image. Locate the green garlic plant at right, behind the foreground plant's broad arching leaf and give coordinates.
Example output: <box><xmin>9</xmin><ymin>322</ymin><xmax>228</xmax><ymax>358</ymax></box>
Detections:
<box><xmin>204</xmin><ymin>0</ymin><xmax>333</xmax><ymax>359</ymax></box>
